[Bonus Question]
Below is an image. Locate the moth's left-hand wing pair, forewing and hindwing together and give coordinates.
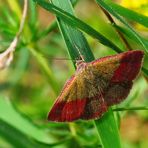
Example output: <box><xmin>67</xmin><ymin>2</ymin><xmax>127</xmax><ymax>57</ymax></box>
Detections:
<box><xmin>48</xmin><ymin>73</ymin><xmax>107</xmax><ymax>122</ymax></box>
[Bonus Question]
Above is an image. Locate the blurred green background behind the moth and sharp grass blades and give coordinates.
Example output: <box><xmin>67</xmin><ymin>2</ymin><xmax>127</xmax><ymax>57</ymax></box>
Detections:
<box><xmin>0</xmin><ymin>0</ymin><xmax>148</xmax><ymax>148</ymax></box>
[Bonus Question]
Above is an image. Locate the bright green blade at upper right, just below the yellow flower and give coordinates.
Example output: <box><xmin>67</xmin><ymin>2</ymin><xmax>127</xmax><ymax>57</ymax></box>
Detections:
<box><xmin>108</xmin><ymin>2</ymin><xmax>148</xmax><ymax>27</ymax></box>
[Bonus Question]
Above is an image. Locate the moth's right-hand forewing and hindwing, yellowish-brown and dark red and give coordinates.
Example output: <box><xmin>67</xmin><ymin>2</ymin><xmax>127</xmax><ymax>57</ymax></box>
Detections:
<box><xmin>94</xmin><ymin>50</ymin><xmax>144</xmax><ymax>106</ymax></box>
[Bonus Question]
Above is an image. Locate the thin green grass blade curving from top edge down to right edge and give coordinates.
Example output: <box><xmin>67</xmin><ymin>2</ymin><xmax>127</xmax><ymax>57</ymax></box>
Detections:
<box><xmin>96</xmin><ymin>0</ymin><xmax>148</xmax><ymax>53</ymax></box>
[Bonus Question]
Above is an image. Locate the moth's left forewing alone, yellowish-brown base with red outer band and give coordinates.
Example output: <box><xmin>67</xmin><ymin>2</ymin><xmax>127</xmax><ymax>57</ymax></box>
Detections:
<box><xmin>48</xmin><ymin>76</ymin><xmax>86</xmax><ymax>122</ymax></box>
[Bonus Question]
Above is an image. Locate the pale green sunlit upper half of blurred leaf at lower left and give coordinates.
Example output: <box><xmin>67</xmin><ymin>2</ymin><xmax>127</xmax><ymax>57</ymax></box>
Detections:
<box><xmin>0</xmin><ymin>96</ymin><xmax>54</xmax><ymax>143</ymax></box>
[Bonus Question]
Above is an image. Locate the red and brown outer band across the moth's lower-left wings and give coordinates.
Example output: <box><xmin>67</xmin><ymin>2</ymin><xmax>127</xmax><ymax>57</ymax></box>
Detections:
<box><xmin>48</xmin><ymin>97</ymin><xmax>108</xmax><ymax>122</ymax></box>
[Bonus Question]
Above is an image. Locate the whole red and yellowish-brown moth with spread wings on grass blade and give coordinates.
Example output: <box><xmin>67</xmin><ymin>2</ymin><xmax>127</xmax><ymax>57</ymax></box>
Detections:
<box><xmin>48</xmin><ymin>50</ymin><xmax>144</xmax><ymax>122</ymax></box>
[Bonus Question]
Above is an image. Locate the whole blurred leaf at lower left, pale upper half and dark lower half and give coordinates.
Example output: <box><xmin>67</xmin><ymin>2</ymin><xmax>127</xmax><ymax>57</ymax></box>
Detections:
<box><xmin>0</xmin><ymin>96</ymin><xmax>71</xmax><ymax>148</ymax></box>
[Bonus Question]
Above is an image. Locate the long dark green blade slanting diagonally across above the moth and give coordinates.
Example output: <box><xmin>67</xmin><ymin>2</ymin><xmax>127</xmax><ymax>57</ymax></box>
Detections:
<box><xmin>33</xmin><ymin>0</ymin><xmax>122</xmax><ymax>53</ymax></box>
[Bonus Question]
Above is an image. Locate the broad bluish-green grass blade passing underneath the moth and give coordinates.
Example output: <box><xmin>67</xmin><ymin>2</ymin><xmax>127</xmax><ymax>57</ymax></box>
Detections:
<box><xmin>48</xmin><ymin>0</ymin><xmax>120</xmax><ymax>148</ymax></box>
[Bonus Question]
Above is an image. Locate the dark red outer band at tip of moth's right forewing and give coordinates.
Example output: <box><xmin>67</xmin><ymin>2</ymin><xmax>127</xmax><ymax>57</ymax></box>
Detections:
<box><xmin>111</xmin><ymin>50</ymin><xmax>144</xmax><ymax>82</ymax></box>
